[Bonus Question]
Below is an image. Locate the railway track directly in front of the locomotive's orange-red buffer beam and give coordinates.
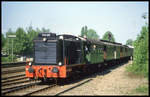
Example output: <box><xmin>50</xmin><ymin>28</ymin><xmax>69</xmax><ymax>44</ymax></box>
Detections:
<box><xmin>2</xmin><ymin>81</ymin><xmax>57</xmax><ymax>96</ymax></box>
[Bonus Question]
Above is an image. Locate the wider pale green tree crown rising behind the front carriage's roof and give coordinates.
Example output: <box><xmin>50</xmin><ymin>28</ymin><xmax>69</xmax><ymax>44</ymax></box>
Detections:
<box><xmin>81</xmin><ymin>26</ymin><xmax>99</xmax><ymax>39</ymax></box>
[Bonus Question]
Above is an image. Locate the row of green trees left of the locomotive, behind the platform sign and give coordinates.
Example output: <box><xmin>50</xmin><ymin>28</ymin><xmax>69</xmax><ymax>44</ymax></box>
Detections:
<box><xmin>2</xmin><ymin>26</ymin><xmax>50</xmax><ymax>61</ymax></box>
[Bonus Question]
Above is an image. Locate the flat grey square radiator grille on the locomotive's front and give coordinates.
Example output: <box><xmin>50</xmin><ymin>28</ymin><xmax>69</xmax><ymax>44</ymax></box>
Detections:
<box><xmin>34</xmin><ymin>42</ymin><xmax>57</xmax><ymax>65</ymax></box>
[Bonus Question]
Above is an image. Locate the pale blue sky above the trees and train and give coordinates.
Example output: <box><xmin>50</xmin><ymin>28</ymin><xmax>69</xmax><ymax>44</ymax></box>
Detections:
<box><xmin>2</xmin><ymin>2</ymin><xmax>149</xmax><ymax>44</ymax></box>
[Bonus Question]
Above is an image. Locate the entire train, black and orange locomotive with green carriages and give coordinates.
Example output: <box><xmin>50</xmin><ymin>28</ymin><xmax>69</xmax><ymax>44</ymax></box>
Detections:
<box><xmin>25</xmin><ymin>33</ymin><xmax>133</xmax><ymax>81</ymax></box>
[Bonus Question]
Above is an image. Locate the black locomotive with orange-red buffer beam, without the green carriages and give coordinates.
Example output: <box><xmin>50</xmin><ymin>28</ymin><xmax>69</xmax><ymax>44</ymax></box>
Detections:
<box><xmin>26</xmin><ymin>33</ymin><xmax>82</xmax><ymax>79</ymax></box>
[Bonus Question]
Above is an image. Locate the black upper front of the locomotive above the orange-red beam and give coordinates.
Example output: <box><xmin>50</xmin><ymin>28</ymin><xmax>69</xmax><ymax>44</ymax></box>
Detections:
<box><xmin>34</xmin><ymin>33</ymin><xmax>64</xmax><ymax>66</ymax></box>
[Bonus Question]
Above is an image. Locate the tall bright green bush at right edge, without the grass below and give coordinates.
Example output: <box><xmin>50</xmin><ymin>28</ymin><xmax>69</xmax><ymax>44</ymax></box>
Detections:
<box><xmin>127</xmin><ymin>26</ymin><xmax>149</xmax><ymax>77</ymax></box>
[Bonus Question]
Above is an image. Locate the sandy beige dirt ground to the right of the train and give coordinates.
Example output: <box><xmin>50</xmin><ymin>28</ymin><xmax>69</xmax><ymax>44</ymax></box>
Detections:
<box><xmin>60</xmin><ymin>61</ymin><xmax>148</xmax><ymax>95</ymax></box>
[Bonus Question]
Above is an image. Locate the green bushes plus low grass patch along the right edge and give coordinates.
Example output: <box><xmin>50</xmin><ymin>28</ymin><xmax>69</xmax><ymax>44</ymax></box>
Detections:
<box><xmin>126</xmin><ymin>18</ymin><xmax>149</xmax><ymax>94</ymax></box>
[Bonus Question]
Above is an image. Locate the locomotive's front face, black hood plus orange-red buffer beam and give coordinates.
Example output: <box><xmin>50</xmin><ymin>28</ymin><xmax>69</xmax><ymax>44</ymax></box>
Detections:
<box><xmin>26</xmin><ymin>33</ymin><xmax>66</xmax><ymax>79</ymax></box>
